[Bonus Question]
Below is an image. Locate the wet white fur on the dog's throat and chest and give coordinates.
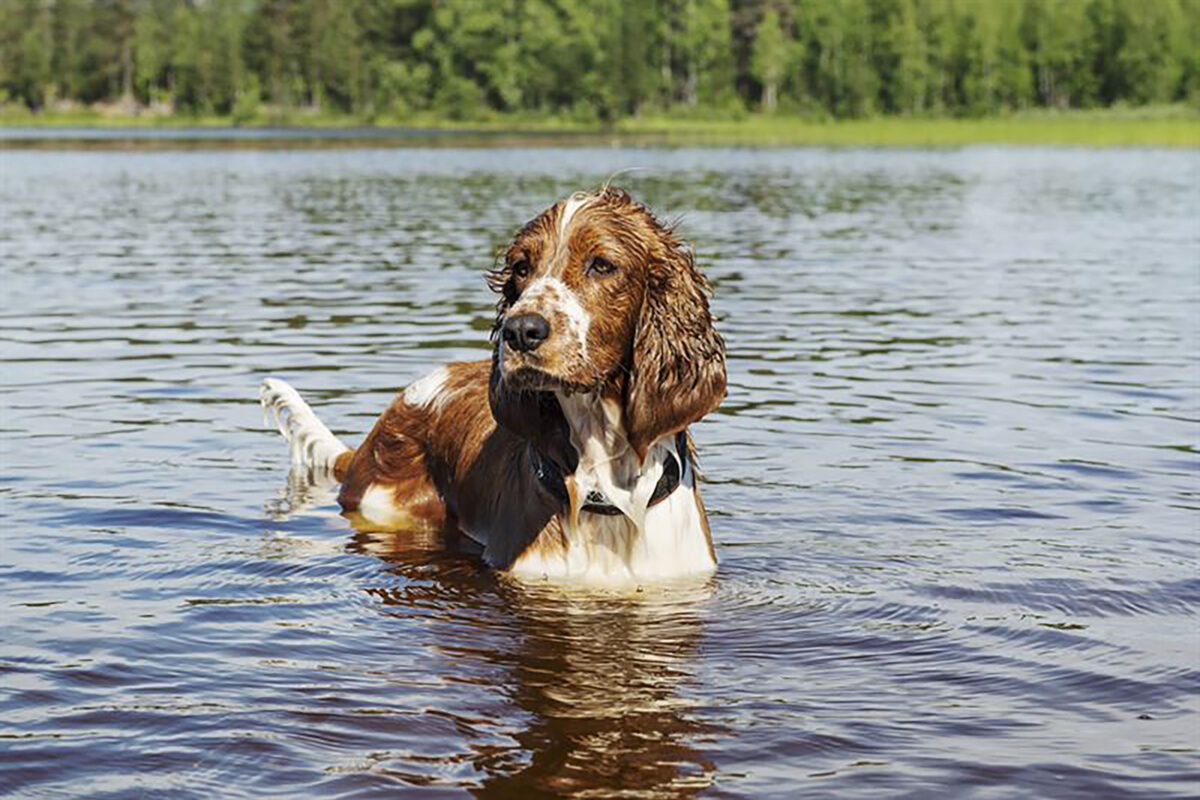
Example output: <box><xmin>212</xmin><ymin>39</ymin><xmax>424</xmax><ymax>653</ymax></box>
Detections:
<box><xmin>510</xmin><ymin>395</ymin><xmax>716</xmax><ymax>584</ymax></box>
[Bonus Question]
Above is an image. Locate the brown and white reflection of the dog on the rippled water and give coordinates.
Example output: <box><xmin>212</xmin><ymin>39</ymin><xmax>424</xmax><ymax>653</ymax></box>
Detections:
<box><xmin>368</xmin><ymin>547</ymin><xmax>715</xmax><ymax>796</ymax></box>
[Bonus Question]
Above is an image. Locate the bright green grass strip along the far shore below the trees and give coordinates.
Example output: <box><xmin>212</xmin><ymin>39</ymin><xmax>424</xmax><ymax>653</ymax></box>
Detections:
<box><xmin>0</xmin><ymin>106</ymin><xmax>1200</xmax><ymax>148</ymax></box>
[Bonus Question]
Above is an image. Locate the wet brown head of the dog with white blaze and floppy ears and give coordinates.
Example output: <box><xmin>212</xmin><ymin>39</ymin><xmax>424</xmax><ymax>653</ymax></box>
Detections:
<box><xmin>488</xmin><ymin>188</ymin><xmax>725</xmax><ymax>458</ymax></box>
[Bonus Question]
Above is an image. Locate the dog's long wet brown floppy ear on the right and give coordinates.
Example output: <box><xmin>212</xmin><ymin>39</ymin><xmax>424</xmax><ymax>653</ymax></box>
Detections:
<box><xmin>625</xmin><ymin>242</ymin><xmax>725</xmax><ymax>459</ymax></box>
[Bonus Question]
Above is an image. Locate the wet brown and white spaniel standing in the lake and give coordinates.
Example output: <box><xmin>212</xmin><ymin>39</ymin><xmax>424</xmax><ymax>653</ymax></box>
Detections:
<box><xmin>262</xmin><ymin>187</ymin><xmax>725</xmax><ymax>583</ymax></box>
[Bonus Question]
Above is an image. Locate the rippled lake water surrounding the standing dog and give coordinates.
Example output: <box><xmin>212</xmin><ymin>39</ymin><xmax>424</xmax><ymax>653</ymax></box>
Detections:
<box><xmin>0</xmin><ymin>144</ymin><xmax>1200</xmax><ymax>799</ymax></box>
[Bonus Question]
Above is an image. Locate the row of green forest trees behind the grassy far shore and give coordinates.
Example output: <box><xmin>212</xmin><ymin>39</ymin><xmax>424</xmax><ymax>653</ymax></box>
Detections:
<box><xmin>0</xmin><ymin>0</ymin><xmax>1200</xmax><ymax>120</ymax></box>
